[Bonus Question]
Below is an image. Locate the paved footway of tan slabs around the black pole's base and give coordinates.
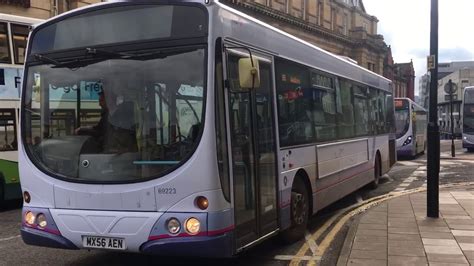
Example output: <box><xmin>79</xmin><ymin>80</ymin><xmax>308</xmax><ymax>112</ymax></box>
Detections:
<box><xmin>337</xmin><ymin>183</ymin><xmax>474</xmax><ymax>266</ymax></box>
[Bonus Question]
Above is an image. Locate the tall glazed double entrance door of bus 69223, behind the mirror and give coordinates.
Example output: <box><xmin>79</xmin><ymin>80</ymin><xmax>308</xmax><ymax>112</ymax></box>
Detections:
<box><xmin>227</xmin><ymin>52</ymin><xmax>278</xmax><ymax>250</ymax></box>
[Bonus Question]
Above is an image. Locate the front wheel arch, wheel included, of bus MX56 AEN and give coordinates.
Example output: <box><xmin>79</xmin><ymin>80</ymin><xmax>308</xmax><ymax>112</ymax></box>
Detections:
<box><xmin>281</xmin><ymin>169</ymin><xmax>313</xmax><ymax>243</ymax></box>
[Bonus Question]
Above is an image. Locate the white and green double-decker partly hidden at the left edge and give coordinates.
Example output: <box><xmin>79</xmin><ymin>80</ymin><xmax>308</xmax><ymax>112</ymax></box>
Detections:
<box><xmin>0</xmin><ymin>13</ymin><xmax>41</xmax><ymax>206</ymax></box>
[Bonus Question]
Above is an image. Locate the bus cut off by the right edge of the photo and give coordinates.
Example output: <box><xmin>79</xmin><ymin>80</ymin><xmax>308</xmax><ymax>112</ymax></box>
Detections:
<box><xmin>462</xmin><ymin>86</ymin><xmax>474</xmax><ymax>152</ymax></box>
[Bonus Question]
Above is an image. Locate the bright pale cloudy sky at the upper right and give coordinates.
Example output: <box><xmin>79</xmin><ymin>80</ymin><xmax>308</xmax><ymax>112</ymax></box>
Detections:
<box><xmin>363</xmin><ymin>0</ymin><xmax>474</xmax><ymax>95</ymax></box>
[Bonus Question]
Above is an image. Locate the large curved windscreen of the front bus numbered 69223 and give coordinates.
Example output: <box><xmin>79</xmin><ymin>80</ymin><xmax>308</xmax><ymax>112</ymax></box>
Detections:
<box><xmin>23</xmin><ymin>46</ymin><xmax>206</xmax><ymax>182</ymax></box>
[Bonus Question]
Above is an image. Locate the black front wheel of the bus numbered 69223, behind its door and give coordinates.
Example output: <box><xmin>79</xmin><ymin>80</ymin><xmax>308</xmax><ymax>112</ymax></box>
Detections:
<box><xmin>281</xmin><ymin>176</ymin><xmax>309</xmax><ymax>243</ymax></box>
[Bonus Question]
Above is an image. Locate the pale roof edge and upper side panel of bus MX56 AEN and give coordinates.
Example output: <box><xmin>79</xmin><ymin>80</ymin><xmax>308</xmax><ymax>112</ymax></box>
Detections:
<box><xmin>28</xmin><ymin>0</ymin><xmax>392</xmax><ymax>92</ymax></box>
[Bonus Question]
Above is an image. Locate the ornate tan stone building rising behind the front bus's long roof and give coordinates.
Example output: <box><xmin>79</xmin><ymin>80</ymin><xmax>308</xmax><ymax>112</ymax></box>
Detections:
<box><xmin>221</xmin><ymin>0</ymin><xmax>387</xmax><ymax>74</ymax></box>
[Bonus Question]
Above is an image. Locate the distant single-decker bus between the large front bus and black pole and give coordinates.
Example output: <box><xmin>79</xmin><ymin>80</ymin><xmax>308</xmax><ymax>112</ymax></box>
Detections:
<box><xmin>395</xmin><ymin>98</ymin><xmax>428</xmax><ymax>158</ymax></box>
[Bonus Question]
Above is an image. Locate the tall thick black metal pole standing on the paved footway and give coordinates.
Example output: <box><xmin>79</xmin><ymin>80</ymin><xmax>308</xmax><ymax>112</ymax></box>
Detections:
<box><xmin>426</xmin><ymin>0</ymin><xmax>439</xmax><ymax>218</ymax></box>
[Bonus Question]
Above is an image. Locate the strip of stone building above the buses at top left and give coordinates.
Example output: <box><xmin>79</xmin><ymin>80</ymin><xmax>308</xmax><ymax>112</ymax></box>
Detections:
<box><xmin>0</xmin><ymin>0</ymin><xmax>104</xmax><ymax>19</ymax></box>
